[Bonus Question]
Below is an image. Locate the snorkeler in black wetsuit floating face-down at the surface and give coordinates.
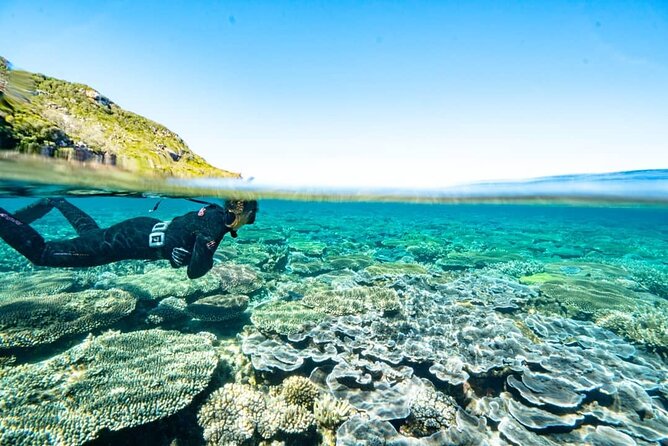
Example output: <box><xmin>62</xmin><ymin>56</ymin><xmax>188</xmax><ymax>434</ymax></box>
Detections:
<box><xmin>0</xmin><ymin>198</ymin><xmax>258</xmax><ymax>279</ymax></box>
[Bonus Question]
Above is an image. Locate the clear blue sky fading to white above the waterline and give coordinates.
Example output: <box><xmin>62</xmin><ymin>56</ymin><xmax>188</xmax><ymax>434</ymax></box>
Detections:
<box><xmin>0</xmin><ymin>0</ymin><xmax>668</xmax><ymax>187</ymax></box>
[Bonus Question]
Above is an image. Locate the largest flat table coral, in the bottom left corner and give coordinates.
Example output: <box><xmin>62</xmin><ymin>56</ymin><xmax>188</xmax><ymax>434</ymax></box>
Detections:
<box><xmin>0</xmin><ymin>329</ymin><xmax>217</xmax><ymax>445</ymax></box>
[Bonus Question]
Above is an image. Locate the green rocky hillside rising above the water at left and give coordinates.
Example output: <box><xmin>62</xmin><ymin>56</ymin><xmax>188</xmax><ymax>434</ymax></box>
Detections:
<box><xmin>0</xmin><ymin>56</ymin><xmax>241</xmax><ymax>178</ymax></box>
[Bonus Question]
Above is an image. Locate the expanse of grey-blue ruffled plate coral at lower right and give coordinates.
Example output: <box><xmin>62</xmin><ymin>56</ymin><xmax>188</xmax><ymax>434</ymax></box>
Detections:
<box><xmin>242</xmin><ymin>274</ymin><xmax>668</xmax><ymax>444</ymax></box>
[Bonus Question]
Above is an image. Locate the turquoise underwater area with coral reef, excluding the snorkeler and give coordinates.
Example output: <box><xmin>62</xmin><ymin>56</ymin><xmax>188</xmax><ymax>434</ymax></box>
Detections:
<box><xmin>0</xmin><ymin>194</ymin><xmax>668</xmax><ymax>446</ymax></box>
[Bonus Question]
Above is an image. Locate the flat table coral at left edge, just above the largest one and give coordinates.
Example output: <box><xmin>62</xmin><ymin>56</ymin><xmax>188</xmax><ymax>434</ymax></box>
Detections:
<box><xmin>0</xmin><ymin>289</ymin><xmax>135</xmax><ymax>349</ymax></box>
